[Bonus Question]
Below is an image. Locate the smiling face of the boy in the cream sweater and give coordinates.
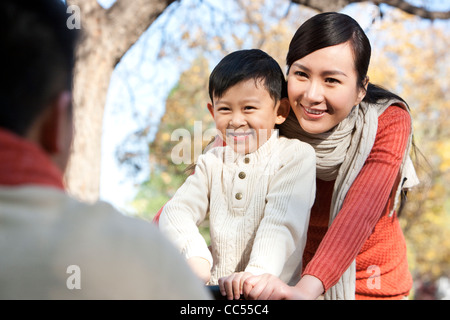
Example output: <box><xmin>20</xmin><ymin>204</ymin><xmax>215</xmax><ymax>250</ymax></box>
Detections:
<box><xmin>208</xmin><ymin>79</ymin><xmax>289</xmax><ymax>154</ymax></box>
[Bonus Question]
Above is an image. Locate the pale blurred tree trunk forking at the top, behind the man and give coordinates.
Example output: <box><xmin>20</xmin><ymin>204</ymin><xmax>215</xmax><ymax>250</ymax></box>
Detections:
<box><xmin>65</xmin><ymin>0</ymin><xmax>174</xmax><ymax>201</ymax></box>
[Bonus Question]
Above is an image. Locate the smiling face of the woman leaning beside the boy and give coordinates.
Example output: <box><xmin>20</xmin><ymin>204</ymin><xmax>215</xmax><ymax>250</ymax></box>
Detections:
<box><xmin>287</xmin><ymin>42</ymin><xmax>366</xmax><ymax>134</ymax></box>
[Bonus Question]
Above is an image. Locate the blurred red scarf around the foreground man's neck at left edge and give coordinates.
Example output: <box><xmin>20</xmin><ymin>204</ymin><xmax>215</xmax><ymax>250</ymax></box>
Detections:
<box><xmin>0</xmin><ymin>128</ymin><xmax>64</xmax><ymax>190</ymax></box>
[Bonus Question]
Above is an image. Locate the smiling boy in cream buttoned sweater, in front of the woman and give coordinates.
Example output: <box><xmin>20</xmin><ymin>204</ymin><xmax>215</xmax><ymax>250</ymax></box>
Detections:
<box><xmin>159</xmin><ymin>50</ymin><xmax>316</xmax><ymax>299</ymax></box>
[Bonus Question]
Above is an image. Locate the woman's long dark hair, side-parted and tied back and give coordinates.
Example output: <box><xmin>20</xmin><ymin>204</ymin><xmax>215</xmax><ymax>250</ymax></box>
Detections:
<box><xmin>286</xmin><ymin>12</ymin><xmax>403</xmax><ymax>103</ymax></box>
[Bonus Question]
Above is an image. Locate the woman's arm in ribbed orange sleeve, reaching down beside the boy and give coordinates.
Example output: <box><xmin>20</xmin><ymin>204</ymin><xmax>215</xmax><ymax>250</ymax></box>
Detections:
<box><xmin>303</xmin><ymin>106</ymin><xmax>411</xmax><ymax>290</ymax></box>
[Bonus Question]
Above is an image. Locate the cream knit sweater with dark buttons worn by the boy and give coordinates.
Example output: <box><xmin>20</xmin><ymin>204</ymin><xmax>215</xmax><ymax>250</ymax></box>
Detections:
<box><xmin>159</xmin><ymin>134</ymin><xmax>316</xmax><ymax>284</ymax></box>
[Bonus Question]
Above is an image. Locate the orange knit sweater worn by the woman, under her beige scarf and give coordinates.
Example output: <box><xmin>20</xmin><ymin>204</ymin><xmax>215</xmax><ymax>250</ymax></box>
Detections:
<box><xmin>303</xmin><ymin>106</ymin><xmax>412</xmax><ymax>299</ymax></box>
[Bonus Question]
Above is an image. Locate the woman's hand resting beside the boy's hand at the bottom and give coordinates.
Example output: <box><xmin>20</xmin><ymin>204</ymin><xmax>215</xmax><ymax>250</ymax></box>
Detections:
<box><xmin>244</xmin><ymin>274</ymin><xmax>323</xmax><ymax>300</ymax></box>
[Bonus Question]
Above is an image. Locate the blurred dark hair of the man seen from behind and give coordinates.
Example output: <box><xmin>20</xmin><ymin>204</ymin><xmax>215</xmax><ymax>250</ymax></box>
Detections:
<box><xmin>0</xmin><ymin>0</ymin><xmax>79</xmax><ymax>136</ymax></box>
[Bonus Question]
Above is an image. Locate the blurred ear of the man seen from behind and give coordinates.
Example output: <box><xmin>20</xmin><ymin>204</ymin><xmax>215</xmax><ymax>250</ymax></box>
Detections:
<box><xmin>40</xmin><ymin>91</ymin><xmax>73</xmax><ymax>155</ymax></box>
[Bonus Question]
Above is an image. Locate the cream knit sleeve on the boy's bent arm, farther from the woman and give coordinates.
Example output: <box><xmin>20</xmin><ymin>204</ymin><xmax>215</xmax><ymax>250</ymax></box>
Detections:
<box><xmin>159</xmin><ymin>156</ymin><xmax>212</xmax><ymax>272</ymax></box>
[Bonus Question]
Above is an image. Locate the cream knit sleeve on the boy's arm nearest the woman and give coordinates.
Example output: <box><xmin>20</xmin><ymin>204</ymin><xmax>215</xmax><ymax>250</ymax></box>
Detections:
<box><xmin>245</xmin><ymin>141</ymin><xmax>316</xmax><ymax>281</ymax></box>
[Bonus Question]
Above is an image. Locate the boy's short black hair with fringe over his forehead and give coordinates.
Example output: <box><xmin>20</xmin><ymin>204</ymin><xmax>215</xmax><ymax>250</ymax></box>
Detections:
<box><xmin>209</xmin><ymin>49</ymin><xmax>287</xmax><ymax>103</ymax></box>
